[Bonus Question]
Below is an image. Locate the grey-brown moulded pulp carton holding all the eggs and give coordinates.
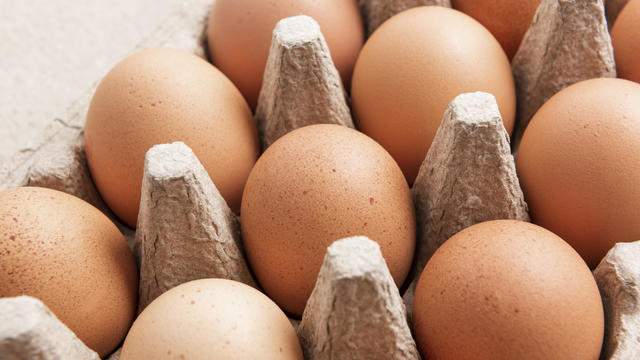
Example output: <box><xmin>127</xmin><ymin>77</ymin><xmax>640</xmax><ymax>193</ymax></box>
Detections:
<box><xmin>0</xmin><ymin>0</ymin><xmax>640</xmax><ymax>359</ymax></box>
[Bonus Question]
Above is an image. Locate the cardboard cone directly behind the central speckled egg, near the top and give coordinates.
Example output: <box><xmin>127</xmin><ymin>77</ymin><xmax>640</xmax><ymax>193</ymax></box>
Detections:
<box><xmin>255</xmin><ymin>15</ymin><xmax>354</xmax><ymax>150</ymax></box>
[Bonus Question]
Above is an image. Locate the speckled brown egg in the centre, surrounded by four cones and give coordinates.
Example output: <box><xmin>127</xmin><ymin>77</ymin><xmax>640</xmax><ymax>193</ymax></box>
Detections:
<box><xmin>241</xmin><ymin>125</ymin><xmax>415</xmax><ymax>316</ymax></box>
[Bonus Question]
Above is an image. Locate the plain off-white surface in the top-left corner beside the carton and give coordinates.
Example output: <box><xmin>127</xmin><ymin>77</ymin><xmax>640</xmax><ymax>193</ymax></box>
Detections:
<box><xmin>0</xmin><ymin>0</ymin><xmax>182</xmax><ymax>164</ymax></box>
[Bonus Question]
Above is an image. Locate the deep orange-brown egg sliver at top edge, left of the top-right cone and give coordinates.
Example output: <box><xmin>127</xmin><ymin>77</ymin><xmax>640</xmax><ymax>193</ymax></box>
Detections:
<box><xmin>451</xmin><ymin>0</ymin><xmax>541</xmax><ymax>59</ymax></box>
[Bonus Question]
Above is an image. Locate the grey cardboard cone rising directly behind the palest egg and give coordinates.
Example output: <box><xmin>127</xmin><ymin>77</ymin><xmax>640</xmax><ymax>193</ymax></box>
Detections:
<box><xmin>135</xmin><ymin>142</ymin><xmax>255</xmax><ymax>311</ymax></box>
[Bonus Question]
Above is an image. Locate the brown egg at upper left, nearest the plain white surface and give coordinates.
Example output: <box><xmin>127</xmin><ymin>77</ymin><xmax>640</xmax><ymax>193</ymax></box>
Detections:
<box><xmin>85</xmin><ymin>49</ymin><xmax>259</xmax><ymax>227</ymax></box>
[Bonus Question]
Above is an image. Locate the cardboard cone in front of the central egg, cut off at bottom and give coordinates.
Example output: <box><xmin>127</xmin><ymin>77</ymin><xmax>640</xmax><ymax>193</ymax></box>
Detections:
<box><xmin>298</xmin><ymin>236</ymin><xmax>420</xmax><ymax>360</ymax></box>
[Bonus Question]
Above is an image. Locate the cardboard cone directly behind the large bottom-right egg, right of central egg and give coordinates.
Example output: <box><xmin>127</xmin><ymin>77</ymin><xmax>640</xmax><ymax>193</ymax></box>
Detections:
<box><xmin>404</xmin><ymin>92</ymin><xmax>530</xmax><ymax>320</ymax></box>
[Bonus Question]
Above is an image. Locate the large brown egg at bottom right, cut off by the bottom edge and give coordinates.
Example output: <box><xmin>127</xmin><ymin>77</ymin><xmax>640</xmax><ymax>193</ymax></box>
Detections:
<box><xmin>413</xmin><ymin>220</ymin><xmax>604</xmax><ymax>360</ymax></box>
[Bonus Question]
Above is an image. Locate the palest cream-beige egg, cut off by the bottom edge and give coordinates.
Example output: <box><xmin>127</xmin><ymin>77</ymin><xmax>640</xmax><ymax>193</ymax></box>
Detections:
<box><xmin>120</xmin><ymin>279</ymin><xmax>303</xmax><ymax>360</ymax></box>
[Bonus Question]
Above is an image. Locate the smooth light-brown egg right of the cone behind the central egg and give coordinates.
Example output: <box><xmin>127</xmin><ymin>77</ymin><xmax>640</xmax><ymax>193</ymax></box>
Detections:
<box><xmin>351</xmin><ymin>6</ymin><xmax>516</xmax><ymax>184</ymax></box>
